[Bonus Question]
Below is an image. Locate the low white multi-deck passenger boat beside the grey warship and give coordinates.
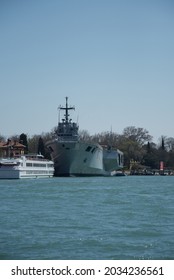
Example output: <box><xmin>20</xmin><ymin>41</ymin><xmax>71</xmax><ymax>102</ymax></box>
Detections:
<box><xmin>0</xmin><ymin>154</ymin><xmax>54</xmax><ymax>179</ymax></box>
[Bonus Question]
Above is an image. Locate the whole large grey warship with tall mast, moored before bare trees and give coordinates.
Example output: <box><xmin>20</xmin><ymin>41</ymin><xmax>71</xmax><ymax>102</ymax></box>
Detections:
<box><xmin>46</xmin><ymin>97</ymin><xmax>123</xmax><ymax>176</ymax></box>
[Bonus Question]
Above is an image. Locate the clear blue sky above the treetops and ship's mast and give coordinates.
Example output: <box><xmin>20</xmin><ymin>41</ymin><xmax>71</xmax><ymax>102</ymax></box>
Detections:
<box><xmin>0</xmin><ymin>0</ymin><xmax>174</xmax><ymax>142</ymax></box>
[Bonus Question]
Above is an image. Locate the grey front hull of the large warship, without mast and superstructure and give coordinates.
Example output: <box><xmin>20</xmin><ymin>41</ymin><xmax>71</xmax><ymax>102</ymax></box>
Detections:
<box><xmin>47</xmin><ymin>140</ymin><xmax>105</xmax><ymax>176</ymax></box>
